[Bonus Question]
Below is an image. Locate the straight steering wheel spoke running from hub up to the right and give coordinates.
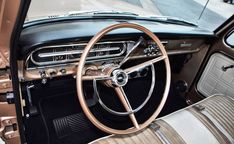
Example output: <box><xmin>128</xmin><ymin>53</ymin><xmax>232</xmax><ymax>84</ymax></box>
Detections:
<box><xmin>124</xmin><ymin>55</ymin><xmax>167</xmax><ymax>74</ymax></box>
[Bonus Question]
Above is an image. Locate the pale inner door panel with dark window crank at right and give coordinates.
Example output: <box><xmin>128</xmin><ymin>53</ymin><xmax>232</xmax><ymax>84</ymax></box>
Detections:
<box><xmin>197</xmin><ymin>53</ymin><xmax>234</xmax><ymax>98</ymax></box>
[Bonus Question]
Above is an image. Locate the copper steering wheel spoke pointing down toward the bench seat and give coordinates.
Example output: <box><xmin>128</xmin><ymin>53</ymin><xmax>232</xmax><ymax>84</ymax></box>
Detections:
<box><xmin>115</xmin><ymin>87</ymin><xmax>140</xmax><ymax>129</ymax></box>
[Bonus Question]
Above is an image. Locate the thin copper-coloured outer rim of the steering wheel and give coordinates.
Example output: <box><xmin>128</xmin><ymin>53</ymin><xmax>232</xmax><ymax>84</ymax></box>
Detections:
<box><xmin>76</xmin><ymin>23</ymin><xmax>171</xmax><ymax>134</ymax></box>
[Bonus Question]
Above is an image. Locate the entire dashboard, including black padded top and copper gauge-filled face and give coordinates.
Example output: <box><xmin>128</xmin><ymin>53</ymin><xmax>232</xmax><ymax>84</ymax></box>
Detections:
<box><xmin>18</xmin><ymin>20</ymin><xmax>216</xmax><ymax>81</ymax></box>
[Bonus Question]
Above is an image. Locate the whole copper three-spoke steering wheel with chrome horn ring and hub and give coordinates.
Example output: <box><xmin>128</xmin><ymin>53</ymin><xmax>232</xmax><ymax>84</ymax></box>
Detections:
<box><xmin>76</xmin><ymin>23</ymin><xmax>171</xmax><ymax>134</ymax></box>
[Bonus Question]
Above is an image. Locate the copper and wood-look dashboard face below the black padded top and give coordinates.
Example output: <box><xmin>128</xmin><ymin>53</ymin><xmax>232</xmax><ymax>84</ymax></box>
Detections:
<box><xmin>18</xmin><ymin>37</ymin><xmax>206</xmax><ymax>82</ymax></box>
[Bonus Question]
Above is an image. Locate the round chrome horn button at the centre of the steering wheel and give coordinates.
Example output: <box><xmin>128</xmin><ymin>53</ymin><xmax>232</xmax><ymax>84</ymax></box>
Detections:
<box><xmin>111</xmin><ymin>69</ymin><xmax>128</xmax><ymax>87</ymax></box>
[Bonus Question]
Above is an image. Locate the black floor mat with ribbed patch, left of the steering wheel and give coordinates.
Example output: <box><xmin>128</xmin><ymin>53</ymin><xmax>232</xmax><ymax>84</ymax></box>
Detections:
<box><xmin>40</xmin><ymin>93</ymin><xmax>106</xmax><ymax>144</ymax></box>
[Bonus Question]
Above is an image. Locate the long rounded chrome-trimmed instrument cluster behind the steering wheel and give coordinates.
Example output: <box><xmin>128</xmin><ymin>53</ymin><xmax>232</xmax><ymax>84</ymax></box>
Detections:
<box><xmin>30</xmin><ymin>41</ymin><xmax>127</xmax><ymax>66</ymax></box>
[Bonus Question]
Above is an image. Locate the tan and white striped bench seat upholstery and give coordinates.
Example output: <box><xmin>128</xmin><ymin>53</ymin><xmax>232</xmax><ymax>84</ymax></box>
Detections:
<box><xmin>92</xmin><ymin>95</ymin><xmax>234</xmax><ymax>144</ymax></box>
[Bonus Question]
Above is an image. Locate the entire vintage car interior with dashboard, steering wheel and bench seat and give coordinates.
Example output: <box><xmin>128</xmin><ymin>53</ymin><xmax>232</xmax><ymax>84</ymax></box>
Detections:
<box><xmin>0</xmin><ymin>0</ymin><xmax>234</xmax><ymax>144</ymax></box>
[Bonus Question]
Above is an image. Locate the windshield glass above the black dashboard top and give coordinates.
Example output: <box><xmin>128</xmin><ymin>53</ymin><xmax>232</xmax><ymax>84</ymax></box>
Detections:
<box><xmin>26</xmin><ymin>0</ymin><xmax>234</xmax><ymax>31</ymax></box>
